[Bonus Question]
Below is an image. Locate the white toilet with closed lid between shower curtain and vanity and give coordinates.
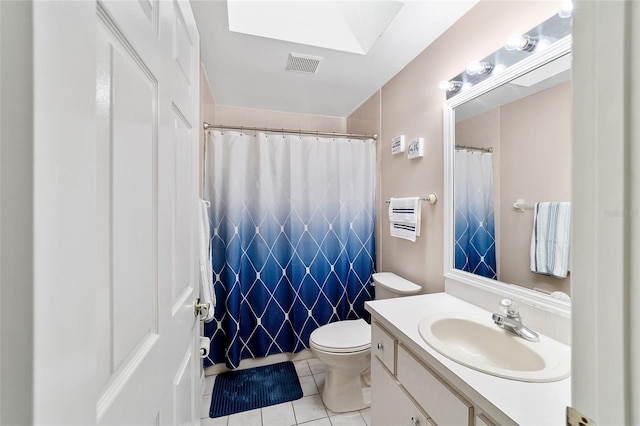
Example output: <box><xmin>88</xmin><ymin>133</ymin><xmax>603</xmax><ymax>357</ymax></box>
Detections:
<box><xmin>309</xmin><ymin>272</ymin><xmax>422</xmax><ymax>413</ymax></box>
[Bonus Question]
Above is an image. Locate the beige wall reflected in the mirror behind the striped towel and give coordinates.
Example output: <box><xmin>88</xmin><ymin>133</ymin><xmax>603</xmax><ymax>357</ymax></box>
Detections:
<box><xmin>500</xmin><ymin>82</ymin><xmax>572</xmax><ymax>294</ymax></box>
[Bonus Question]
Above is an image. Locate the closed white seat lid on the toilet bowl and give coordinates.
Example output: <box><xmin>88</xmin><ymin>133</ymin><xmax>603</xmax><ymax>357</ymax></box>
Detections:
<box><xmin>309</xmin><ymin>319</ymin><xmax>371</xmax><ymax>353</ymax></box>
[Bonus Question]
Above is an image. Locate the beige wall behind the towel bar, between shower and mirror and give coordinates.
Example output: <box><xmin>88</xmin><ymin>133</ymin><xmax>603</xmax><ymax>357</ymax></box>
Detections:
<box><xmin>352</xmin><ymin>1</ymin><xmax>561</xmax><ymax>292</ymax></box>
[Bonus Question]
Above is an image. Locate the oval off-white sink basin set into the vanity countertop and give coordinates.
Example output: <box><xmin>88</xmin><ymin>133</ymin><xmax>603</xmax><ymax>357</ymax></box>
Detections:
<box><xmin>418</xmin><ymin>313</ymin><xmax>571</xmax><ymax>382</ymax></box>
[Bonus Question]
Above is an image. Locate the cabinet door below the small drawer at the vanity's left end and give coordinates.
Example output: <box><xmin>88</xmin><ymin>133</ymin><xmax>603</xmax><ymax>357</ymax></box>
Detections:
<box><xmin>371</xmin><ymin>357</ymin><xmax>432</xmax><ymax>426</ymax></box>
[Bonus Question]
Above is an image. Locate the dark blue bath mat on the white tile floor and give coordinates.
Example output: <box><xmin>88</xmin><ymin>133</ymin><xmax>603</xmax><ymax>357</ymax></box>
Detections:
<box><xmin>209</xmin><ymin>361</ymin><xmax>302</xmax><ymax>417</ymax></box>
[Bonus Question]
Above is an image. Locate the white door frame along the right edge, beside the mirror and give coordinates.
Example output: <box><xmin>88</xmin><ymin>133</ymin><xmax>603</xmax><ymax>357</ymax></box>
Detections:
<box><xmin>571</xmin><ymin>1</ymin><xmax>640</xmax><ymax>424</ymax></box>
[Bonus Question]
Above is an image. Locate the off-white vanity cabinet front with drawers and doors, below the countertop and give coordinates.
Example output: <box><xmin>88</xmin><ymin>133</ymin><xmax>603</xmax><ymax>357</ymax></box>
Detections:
<box><xmin>371</xmin><ymin>320</ymin><xmax>494</xmax><ymax>426</ymax></box>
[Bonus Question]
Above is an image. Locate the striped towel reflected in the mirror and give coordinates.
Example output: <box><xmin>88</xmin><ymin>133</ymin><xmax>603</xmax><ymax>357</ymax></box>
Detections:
<box><xmin>530</xmin><ymin>202</ymin><xmax>571</xmax><ymax>278</ymax></box>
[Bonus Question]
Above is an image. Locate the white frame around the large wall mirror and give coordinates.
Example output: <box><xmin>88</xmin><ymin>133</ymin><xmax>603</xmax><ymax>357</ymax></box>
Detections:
<box><xmin>443</xmin><ymin>35</ymin><xmax>571</xmax><ymax>318</ymax></box>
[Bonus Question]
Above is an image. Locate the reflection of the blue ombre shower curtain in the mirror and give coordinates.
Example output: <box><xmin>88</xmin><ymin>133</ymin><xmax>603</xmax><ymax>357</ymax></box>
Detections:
<box><xmin>454</xmin><ymin>150</ymin><xmax>498</xmax><ymax>280</ymax></box>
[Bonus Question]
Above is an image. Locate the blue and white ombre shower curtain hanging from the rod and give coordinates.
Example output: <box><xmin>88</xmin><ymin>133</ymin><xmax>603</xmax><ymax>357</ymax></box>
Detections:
<box><xmin>204</xmin><ymin>131</ymin><xmax>375</xmax><ymax>368</ymax></box>
